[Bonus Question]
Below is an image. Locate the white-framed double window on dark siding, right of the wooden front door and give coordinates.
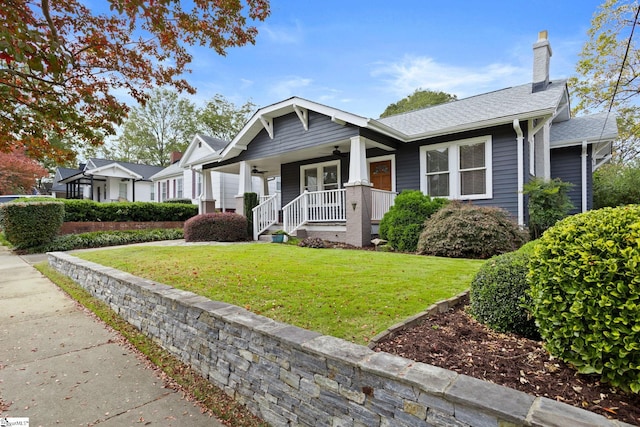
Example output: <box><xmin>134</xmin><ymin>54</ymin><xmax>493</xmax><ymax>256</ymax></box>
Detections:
<box><xmin>420</xmin><ymin>136</ymin><xmax>493</xmax><ymax>200</ymax></box>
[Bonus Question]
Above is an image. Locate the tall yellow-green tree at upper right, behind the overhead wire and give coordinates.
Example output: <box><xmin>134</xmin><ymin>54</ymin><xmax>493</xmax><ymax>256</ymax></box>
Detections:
<box><xmin>569</xmin><ymin>0</ymin><xmax>640</xmax><ymax>162</ymax></box>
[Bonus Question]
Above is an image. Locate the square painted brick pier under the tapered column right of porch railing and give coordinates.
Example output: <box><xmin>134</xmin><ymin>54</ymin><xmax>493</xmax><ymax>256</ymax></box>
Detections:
<box><xmin>344</xmin><ymin>183</ymin><xmax>371</xmax><ymax>247</ymax></box>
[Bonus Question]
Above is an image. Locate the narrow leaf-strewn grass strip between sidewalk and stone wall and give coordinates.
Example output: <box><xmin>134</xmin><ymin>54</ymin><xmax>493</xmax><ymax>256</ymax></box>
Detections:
<box><xmin>35</xmin><ymin>263</ymin><xmax>267</xmax><ymax>427</ymax></box>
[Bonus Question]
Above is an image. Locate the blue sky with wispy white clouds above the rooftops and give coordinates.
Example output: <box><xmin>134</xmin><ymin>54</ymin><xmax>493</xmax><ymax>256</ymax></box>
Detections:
<box><xmin>161</xmin><ymin>0</ymin><xmax>602</xmax><ymax>118</ymax></box>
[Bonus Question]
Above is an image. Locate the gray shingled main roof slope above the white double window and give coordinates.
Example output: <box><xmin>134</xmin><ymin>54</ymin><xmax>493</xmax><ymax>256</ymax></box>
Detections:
<box><xmin>377</xmin><ymin>80</ymin><xmax>568</xmax><ymax>141</ymax></box>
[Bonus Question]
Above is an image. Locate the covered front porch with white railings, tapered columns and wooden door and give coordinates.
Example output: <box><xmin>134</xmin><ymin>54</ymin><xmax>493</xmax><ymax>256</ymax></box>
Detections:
<box><xmin>205</xmin><ymin>136</ymin><xmax>396</xmax><ymax>246</ymax></box>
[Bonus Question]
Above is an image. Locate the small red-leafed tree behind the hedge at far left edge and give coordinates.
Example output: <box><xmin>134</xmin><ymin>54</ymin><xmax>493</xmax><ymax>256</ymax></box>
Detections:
<box><xmin>0</xmin><ymin>151</ymin><xmax>49</xmax><ymax>194</ymax></box>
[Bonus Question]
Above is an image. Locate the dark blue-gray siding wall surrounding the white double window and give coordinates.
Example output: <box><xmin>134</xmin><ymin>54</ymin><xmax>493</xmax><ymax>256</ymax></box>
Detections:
<box><xmin>396</xmin><ymin>125</ymin><xmax>518</xmax><ymax>217</ymax></box>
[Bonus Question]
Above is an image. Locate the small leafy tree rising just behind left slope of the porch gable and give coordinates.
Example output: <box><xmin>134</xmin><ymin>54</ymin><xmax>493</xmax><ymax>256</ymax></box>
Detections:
<box><xmin>199</xmin><ymin>94</ymin><xmax>256</xmax><ymax>141</ymax></box>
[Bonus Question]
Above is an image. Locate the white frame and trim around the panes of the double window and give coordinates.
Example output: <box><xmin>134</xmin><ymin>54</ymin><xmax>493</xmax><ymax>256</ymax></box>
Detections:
<box><xmin>420</xmin><ymin>135</ymin><xmax>493</xmax><ymax>200</ymax></box>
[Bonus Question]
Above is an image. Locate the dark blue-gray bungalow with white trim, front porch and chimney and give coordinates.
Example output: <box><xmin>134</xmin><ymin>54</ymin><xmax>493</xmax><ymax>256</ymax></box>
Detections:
<box><xmin>202</xmin><ymin>32</ymin><xmax>617</xmax><ymax>246</ymax></box>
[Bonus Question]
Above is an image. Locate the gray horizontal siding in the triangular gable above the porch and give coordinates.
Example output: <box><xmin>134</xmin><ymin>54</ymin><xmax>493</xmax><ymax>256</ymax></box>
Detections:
<box><xmin>216</xmin><ymin>111</ymin><xmax>358</xmax><ymax>164</ymax></box>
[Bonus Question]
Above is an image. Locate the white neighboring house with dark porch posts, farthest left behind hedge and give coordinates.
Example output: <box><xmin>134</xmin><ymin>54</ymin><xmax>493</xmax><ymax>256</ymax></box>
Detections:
<box><xmin>54</xmin><ymin>158</ymin><xmax>163</xmax><ymax>202</ymax></box>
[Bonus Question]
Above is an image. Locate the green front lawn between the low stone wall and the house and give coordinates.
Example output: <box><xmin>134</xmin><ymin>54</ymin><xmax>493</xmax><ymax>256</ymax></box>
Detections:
<box><xmin>74</xmin><ymin>244</ymin><xmax>483</xmax><ymax>344</ymax></box>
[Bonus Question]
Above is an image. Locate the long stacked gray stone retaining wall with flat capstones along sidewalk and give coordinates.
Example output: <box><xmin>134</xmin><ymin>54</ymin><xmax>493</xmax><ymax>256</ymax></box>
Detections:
<box><xmin>49</xmin><ymin>253</ymin><xmax>623</xmax><ymax>427</ymax></box>
